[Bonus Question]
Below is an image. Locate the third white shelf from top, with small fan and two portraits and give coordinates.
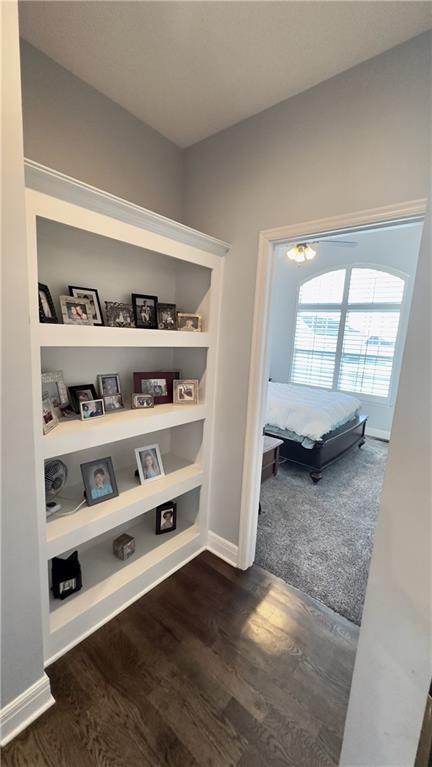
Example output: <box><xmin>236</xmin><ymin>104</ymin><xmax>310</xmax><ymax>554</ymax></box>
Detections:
<box><xmin>46</xmin><ymin>454</ymin><xmax>203</xmax><ymax>559</ymax></box>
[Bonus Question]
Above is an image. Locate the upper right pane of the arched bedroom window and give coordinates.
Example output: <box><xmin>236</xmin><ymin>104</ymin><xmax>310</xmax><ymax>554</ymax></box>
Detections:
<box><xmin>348</xmin><ymin>269</ymin><xmax>405</xmax><ymax>304</ymax></box>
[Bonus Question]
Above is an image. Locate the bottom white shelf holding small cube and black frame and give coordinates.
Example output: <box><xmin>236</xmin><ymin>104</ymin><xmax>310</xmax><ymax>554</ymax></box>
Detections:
<box><xmin>50</xmin><ymin>514</ymin><xmax>199</xmax><ymax>634</ymax></box>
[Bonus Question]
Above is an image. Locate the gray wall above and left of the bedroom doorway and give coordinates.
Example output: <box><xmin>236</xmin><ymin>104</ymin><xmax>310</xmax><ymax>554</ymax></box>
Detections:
<box><xmin>184</xmin><ymin>35</ymin><xmax>430</xmax><ymax>543</ymax></box>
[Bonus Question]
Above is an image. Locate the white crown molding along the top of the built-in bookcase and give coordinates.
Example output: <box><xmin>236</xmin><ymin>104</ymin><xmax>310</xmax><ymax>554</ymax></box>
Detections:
<box><xmin>24</xmin><ymin>158</ymin><xmax>231</xmax><ymax>257</ymax></box>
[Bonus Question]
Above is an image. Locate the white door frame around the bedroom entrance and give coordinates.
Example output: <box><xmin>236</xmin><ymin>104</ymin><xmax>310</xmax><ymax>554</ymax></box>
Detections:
<box><xmin>238</xmin><ymin>199</ymin><xmax>426</xmax><ymax>570</ymax></box>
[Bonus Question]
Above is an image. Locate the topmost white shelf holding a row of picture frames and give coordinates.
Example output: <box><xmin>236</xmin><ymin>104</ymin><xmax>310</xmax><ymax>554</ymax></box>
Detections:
<box><xmin>36</xmin><ymin>323</ymin><xmax>210</xmax><ymax>349</ymax></box>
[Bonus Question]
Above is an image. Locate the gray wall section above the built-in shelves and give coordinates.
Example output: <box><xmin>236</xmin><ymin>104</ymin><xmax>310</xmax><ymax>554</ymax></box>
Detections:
<box><xmin>21</xmin><ymin>41</ymin><xmax>184</xmax><ymax>221</ymax></box>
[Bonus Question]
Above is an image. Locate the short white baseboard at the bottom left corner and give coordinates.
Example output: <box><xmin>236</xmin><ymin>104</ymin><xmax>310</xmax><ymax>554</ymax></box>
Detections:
<box><xmin>0</xmin><ymin>673</ymin><xmax>55</xmax><ymax>746</ymax></box>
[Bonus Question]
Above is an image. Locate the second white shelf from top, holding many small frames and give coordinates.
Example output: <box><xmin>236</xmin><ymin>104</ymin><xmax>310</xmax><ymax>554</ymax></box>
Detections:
<box><xmin>41</xmin><ymin>404</ymin><xmax>207</xmax><ymax>458</ymax></box>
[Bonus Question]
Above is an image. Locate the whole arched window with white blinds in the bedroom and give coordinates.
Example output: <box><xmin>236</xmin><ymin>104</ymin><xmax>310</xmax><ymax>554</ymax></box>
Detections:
<box><xmin>291</xmin><ymin>267</ymin><xmax>405</xmax><ymax>398</ymax></box>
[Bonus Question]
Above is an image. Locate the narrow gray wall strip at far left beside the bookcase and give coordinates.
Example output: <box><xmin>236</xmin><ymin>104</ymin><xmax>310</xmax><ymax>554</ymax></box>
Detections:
<box><xmin>1</xmin><ymin>3</ymin><xmax>43</xmax><ymax>706</ymax></box>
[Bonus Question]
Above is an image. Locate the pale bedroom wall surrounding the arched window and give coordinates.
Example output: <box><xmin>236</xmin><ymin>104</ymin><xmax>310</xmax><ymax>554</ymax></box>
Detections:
<box><xmin>270</xmin><ymin>224</ymin><xmax>423</xmax><ymax>439</ymax></box>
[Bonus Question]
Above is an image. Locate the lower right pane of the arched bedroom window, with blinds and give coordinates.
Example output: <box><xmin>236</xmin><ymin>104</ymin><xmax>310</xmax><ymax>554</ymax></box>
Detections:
<box><xmin>338</xmin><ymin>311</ymin><xmax>399</xmax><ymax>397</ymax></box>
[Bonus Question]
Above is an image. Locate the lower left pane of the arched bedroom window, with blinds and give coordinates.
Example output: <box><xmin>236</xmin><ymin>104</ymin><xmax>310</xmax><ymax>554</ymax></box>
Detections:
<box><xmin>291</xmin><ymin>311</ymin><xmax>340</xmax><ymax>388</ymax></box>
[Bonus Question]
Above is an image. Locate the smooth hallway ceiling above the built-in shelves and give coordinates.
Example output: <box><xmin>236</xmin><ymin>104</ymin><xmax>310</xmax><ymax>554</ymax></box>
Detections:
<box><xmin>20</xmin><ymin>0</ymin><xmax>432</xmax><ymax>147</ymax></box>
